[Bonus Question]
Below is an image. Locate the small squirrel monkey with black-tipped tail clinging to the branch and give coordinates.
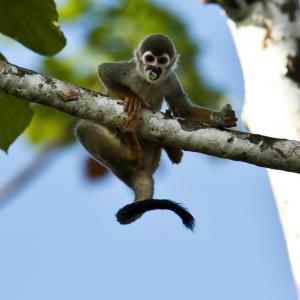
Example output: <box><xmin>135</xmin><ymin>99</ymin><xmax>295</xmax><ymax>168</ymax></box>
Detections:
<box><xmin>75</xmin><ymin>34</ymin><xmax>237</xmax><ymax>230</ymax></box>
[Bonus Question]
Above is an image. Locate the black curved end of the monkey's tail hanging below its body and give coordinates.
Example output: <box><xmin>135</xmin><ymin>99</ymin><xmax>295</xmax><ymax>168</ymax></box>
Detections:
<box><xmin>116</xmin><ymin>199</ymin><xmax>195</xmax><ymax>231</ymax></box>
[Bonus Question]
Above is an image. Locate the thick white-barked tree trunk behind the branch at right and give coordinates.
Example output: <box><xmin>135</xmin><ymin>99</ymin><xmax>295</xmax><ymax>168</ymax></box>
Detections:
<box><xmin>217</xmin><ymin>0</ymin><xmax>300</xmax><ymax>299</ymax></box>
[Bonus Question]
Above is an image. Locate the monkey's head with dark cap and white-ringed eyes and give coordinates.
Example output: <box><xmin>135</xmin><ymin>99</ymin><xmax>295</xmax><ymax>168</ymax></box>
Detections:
<box><xmin>135</xmin><ymin>33</ymin><xmax>178</xmax><ymax>83</ymax></box>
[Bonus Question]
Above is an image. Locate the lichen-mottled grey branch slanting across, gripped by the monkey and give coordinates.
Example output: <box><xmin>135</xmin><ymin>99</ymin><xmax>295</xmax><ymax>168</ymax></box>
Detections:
<box><xmin>0</xmin><ymin>61</ymin><xmax>300</xmax><ymax>173</ymax></box>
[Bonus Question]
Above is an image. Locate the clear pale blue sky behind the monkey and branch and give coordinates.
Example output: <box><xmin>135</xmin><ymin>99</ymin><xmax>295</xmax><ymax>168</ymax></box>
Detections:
<box><xmin>0</xmin><ymin>0</ymin><xmax>296</xmax><ymax>300</ymax></box>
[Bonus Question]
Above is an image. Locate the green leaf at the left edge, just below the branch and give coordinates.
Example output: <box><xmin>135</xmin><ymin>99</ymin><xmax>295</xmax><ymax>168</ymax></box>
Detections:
<box><xmin>0</xmin><ymin>93</ymin><xmax>33</xmax><ymax>152</ymax></box>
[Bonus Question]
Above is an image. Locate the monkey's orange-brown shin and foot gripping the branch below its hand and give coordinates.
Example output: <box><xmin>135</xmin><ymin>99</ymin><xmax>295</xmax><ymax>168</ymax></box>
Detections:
<box><xmin>120</xmin><ymin>115</ymin><xmax>144</xmax><ymax>169</ymax></box>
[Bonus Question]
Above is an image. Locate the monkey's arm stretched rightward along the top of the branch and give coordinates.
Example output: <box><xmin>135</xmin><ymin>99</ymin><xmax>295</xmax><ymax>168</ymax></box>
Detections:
<box><xmin>166</xmin><ymin>74</ymin><xmax>237</xmax><ymax>127</ymax></box>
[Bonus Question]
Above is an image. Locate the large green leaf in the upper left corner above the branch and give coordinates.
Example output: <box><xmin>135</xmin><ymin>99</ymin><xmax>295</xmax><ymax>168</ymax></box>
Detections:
<box><xmin>0</xmin><ymin>0</ymin><xmax>66</xmax><ymax>55</ymax></box>
